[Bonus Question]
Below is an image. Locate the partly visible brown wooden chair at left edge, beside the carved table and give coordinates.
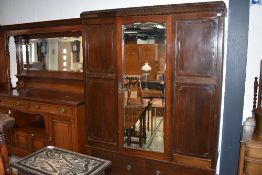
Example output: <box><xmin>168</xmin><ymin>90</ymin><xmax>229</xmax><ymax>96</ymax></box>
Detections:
<box><xmin>0</xmin><ymin>112</ymin><xmax>15</xmax><ymax>175</ymax></box>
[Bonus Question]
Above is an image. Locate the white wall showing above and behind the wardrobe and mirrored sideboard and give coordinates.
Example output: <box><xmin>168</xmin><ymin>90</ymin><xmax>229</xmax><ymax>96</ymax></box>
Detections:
<box><xmin>0</xmin><ymin>0</ymin><xmax>229</xmax><ymax>174</ymax></box>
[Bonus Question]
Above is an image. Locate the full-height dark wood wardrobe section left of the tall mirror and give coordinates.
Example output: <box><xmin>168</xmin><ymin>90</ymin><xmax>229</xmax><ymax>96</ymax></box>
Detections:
<box><xmin>82</xmin><ymin>18</ymin><xmax>117</xmax><ymax>150</ymax></box>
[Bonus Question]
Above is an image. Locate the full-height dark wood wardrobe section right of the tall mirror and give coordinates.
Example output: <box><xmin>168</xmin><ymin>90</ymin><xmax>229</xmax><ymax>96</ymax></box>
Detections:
<box><xmin>172</xmin><ymin>12</ymin><xmax>223</xmax><ymax>169</ymax></box>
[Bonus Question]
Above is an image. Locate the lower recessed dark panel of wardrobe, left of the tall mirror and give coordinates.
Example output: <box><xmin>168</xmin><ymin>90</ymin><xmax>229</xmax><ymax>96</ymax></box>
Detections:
<box><xmin>86</xmin><ymin>79</ymin><xmax>117</xmax><ymax>148</ymax></box>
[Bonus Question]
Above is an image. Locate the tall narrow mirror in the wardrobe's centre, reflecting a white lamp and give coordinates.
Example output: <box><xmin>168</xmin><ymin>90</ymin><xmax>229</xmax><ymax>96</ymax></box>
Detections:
<box><xmin>122</xmin><ymin>22</ymin><xmax>166</xmax><ymax>152</ymax></box>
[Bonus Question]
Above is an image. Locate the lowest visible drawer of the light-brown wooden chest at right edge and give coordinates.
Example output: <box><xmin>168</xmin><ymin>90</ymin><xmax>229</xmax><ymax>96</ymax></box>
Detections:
<box><xmin>245</xmin><ymin>159</ymin><xmax>262</xmax><ymax>175</ymax></box>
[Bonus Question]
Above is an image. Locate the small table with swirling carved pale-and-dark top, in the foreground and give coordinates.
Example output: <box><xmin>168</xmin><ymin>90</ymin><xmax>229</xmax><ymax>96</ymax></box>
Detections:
<box><xmin>11</xmin><ymin>146</ymin><xmax>111</xmax><ymax>175</ymax></box>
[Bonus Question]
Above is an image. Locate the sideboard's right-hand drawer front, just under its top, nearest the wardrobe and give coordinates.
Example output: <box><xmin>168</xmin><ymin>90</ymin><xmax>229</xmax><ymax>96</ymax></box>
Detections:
<box><xmin>28</xmin><ymin>102</ymin><xmax>73</xmax><ymax>116</ymax></box>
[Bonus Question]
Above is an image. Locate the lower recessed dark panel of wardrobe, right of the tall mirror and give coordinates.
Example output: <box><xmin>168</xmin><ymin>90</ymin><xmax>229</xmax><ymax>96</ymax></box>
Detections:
<box><xmin>173</xmin><ymin>84</ymin><xmax>215</xmax><ymax>158</ymax></box>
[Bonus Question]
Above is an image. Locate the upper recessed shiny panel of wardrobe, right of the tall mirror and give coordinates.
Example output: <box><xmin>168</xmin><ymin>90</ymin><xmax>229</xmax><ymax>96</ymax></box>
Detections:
<box><xmin>174</xmin><ymin>14</ymin><xmax>218</xmax><ymax>77</ymax></box>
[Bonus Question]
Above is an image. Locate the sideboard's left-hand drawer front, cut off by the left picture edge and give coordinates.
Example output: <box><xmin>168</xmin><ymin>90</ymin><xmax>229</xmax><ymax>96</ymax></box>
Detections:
<box><xmin>0</xmin><ymin>98</ymin><xmax>27</xmax><ymax>110</ymax></box>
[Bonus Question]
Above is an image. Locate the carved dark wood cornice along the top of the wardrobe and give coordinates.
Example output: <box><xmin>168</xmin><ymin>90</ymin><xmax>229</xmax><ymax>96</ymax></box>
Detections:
<box><xmin>81</xmin><ymin>1</ymin><xmax>226</xmax><ymax>19</ymax></box>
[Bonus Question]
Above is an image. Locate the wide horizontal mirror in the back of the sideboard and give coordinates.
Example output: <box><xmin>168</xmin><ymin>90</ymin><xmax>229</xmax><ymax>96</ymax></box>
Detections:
<box><xmin>22</xmin><ymin>36</ymin><xmax>83</xmax><ymax>72</ymax></box>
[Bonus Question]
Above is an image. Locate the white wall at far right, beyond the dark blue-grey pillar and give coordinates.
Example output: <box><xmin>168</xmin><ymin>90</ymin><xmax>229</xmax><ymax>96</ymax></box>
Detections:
<box><xmin>243</xmin><ymin>6</ymin><xmax>262</xmax><ymax>121</ymax></box>
